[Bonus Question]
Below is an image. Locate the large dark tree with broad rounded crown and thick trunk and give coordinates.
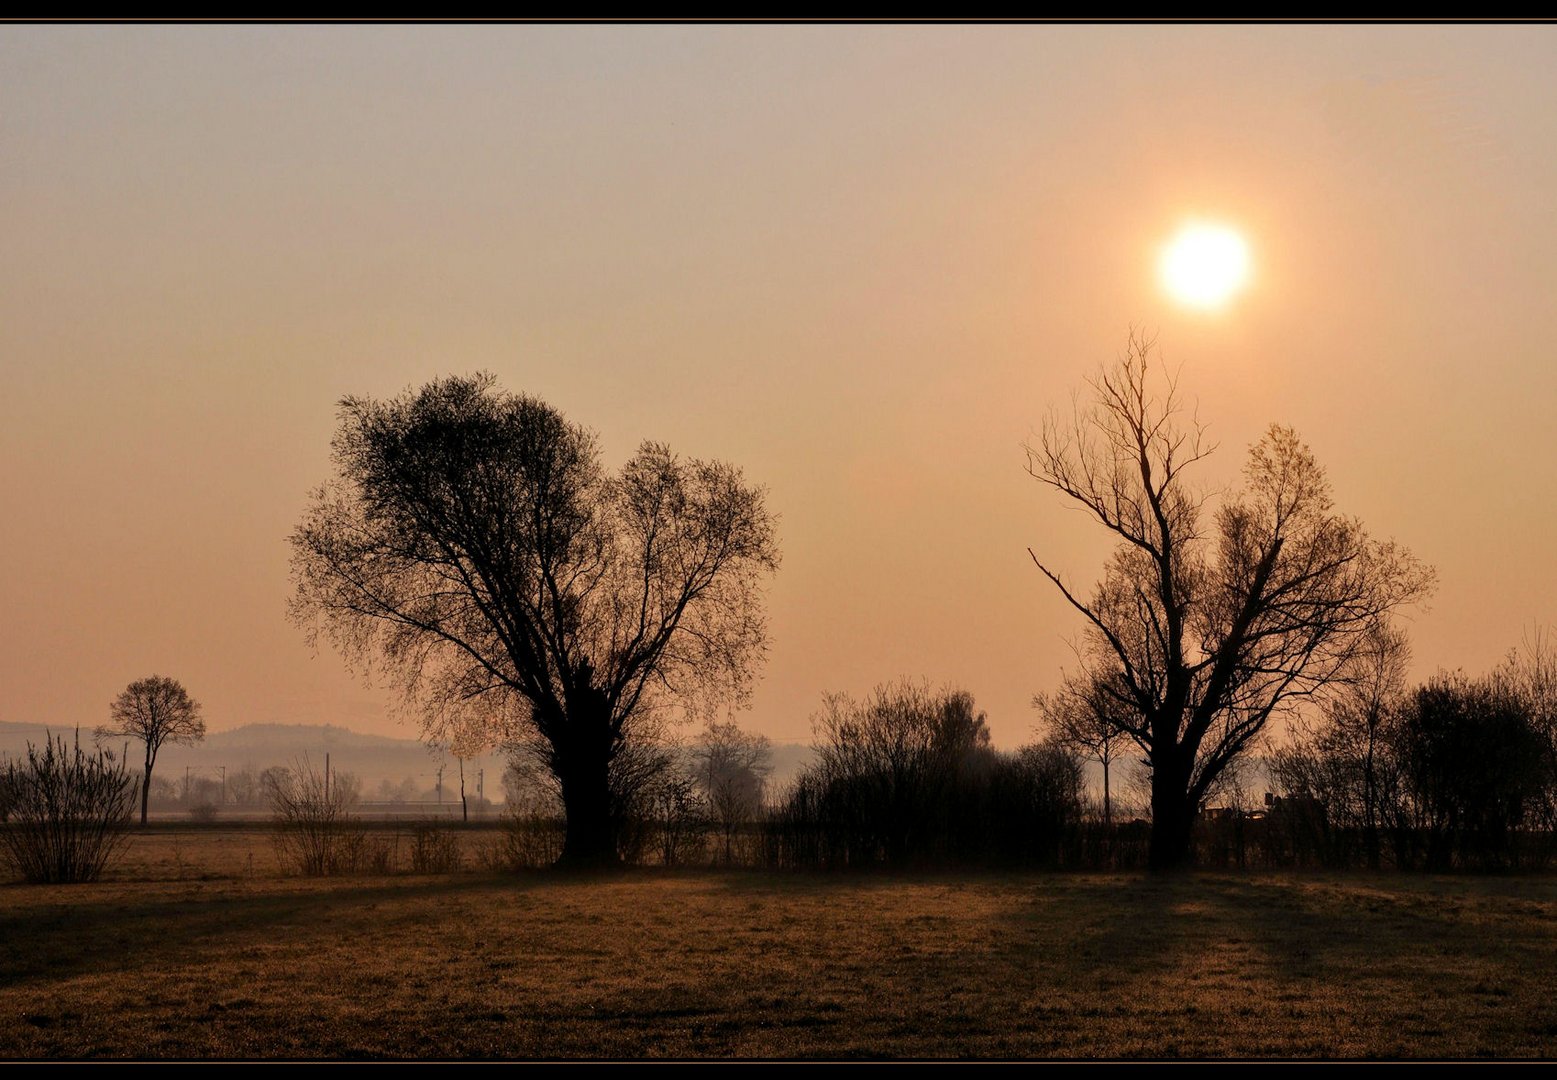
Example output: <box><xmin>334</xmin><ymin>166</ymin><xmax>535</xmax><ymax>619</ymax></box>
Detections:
<box><xmin>291</xmin><ymin>375</ymin><xmax>779</xmax><ymax>865</ymax></box>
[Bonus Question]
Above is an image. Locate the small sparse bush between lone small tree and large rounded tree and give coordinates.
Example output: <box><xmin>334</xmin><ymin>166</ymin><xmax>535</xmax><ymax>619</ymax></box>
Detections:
<box><xmin>265</xmin><ymin>759</ymin><xmax>372</xmax><ymax>878</ymax></box>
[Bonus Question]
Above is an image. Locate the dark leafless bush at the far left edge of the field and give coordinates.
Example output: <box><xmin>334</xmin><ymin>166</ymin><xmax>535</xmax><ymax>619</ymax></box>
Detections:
<box><xmin>0</xmin><ymin>736</ymin><xmax>135</xmax><ymax>882</ymax></box>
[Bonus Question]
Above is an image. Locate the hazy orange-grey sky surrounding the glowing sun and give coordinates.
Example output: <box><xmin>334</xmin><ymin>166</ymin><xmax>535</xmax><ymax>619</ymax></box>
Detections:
<box><xmin>0</xmin><ymin>25</ymin><xmax>1557</xmax><ymax>745</ymax></box>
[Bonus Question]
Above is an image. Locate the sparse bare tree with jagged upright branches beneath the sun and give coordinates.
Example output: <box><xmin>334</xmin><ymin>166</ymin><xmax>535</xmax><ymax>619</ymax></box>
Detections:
<box><xmin>1028</xmin><ymin>333</ymin><xmax>1432</xmax><ymax>868</ymax></box>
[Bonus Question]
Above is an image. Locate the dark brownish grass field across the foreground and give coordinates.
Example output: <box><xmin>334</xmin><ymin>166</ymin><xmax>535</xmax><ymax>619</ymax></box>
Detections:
<box><xmin>0</xmin><ymin>831</ymin><xmax>1557</xmax><ymax>1058</ymax></box>
